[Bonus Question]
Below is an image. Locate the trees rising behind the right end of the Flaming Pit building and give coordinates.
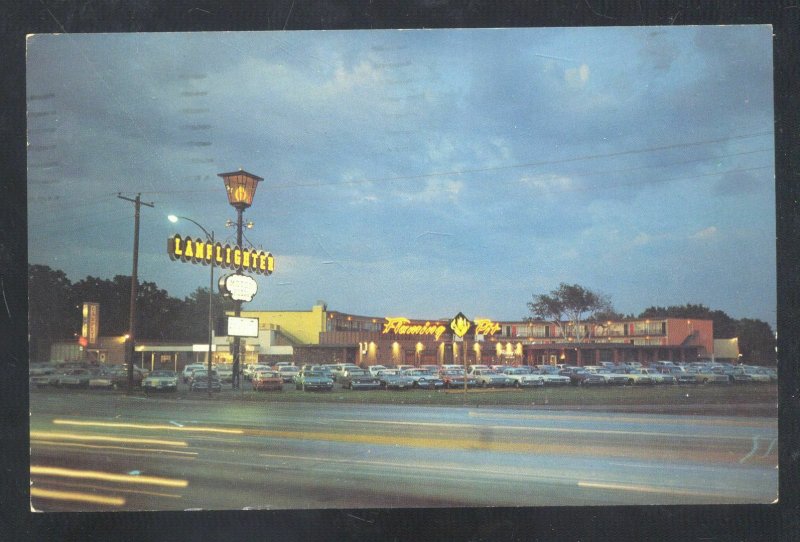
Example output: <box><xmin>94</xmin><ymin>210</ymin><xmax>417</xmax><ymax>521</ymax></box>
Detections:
<box><xmin>527</xmin><ymin>283</ymin><xmax>776</xmax><ymax>365</ymax></box>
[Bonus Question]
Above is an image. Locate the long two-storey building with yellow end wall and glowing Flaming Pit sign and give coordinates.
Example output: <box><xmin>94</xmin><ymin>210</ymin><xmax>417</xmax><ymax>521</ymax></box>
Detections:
<box><xmin>243</xmin><ymin>305</ymin><xmax>714</xmax><ymax>366</ymax></box>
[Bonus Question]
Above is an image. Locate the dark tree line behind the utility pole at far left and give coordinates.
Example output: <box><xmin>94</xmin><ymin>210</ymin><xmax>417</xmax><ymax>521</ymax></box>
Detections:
<box><xmin>28</xmin><ymin>265</ymin><xmax>233</xmax><ymax>361</ymax></box>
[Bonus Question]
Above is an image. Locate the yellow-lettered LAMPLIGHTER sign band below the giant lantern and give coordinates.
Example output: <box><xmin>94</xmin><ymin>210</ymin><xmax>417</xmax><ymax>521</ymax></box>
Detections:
<box><xmin>167</xmin><ymin>234</ymin><xmax>275</xmax><ymax>275</ymax></box>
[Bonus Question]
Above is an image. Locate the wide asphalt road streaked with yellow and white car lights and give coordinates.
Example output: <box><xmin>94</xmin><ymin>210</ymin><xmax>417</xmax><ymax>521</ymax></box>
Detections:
<box><xmin>31</xmin><ymin>391</ymin><xmax>778</xmax><ymax>511</ymax></box>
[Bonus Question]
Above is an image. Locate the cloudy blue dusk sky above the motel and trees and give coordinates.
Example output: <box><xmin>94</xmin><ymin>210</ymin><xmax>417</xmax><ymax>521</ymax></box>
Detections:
<box><xmin>27</xmin><ymin>26</ymin><xmax>776</xmax><ymax>328</ymax></box>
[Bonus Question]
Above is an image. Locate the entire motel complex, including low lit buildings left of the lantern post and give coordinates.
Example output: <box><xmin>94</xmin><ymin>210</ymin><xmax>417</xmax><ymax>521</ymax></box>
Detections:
<box><xmin>51</xmin><ymin>302</ymin><xmax>714</xmax><ymax>371</ymax></box>
